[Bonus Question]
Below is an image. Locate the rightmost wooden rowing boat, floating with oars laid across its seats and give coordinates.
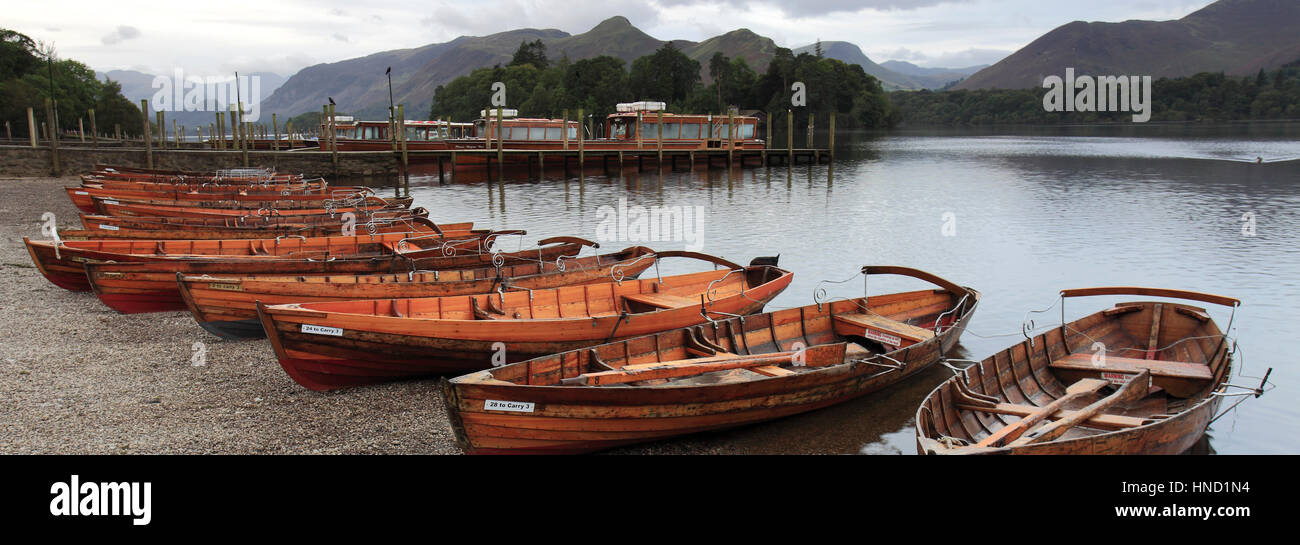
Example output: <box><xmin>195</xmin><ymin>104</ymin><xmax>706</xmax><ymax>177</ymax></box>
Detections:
<box><xmin>915</xmin><ymin>287</ymin><xmax>1240</xmax><ymax>454</ymax></box>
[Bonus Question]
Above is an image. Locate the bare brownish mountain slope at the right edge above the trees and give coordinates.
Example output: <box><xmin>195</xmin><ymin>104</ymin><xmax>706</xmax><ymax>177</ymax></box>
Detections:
<box><xmin>957</xmin><ymin>0</ymin><xmax>1300</xmax><ymax>88</ymax></box>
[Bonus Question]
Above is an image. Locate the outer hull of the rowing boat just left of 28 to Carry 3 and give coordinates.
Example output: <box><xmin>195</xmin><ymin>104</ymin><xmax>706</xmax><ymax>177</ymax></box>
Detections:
<box><xmin>257</xmin><ymin>267</ymin><xmax>792</xmax><ymax>390</ymax></box>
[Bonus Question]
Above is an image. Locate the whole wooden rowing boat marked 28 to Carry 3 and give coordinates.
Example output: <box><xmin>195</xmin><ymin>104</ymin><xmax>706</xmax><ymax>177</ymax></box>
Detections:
<box><xmin>442</xmin><ymin>267</ymin><xmax>979</xmax><ymax>453</ymax></box>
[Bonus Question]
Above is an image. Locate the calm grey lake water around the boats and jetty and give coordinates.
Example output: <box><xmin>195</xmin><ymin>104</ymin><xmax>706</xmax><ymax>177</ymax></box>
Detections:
<box><xmin>377</xmin><ymin>124</ymin><xmax>1300</xmax><ymax>454</ymax></box>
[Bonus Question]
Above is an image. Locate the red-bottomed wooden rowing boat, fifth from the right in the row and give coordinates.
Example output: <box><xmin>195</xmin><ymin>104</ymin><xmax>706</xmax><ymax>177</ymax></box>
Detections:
<box><xmin>82</xmin><ymin>232</ymin><xmax>582</xmax><ymax>313</ymax></box>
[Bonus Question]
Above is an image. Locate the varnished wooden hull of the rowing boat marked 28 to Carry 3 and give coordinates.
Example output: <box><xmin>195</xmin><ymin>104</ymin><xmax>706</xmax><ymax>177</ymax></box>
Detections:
<box><xmin>442</xmin><ymin>283</ymin><xmax>978</xmax><ymax>454</ymax></box>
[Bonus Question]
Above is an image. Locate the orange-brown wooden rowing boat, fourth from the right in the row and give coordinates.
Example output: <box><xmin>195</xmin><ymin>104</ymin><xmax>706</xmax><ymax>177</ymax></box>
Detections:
<box><xmin>177</xmin><ymin>246</ymin><xmax>658</xmax><ymax>338</ymax></box>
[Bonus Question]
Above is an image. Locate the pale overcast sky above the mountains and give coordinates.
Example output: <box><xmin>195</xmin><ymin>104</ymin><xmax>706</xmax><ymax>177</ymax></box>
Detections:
<box><xmin>10</xmin><ymin>0</ymin><xmax>1210</xmax><ymax>77</ymax></box>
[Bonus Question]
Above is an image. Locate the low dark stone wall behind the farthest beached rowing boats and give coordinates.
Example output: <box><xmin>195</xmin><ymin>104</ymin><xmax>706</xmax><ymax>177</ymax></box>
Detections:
<box><xmin>0</xmin><ymin>146</ymin><xmax>400</xmax><ymax>178</ymax></box>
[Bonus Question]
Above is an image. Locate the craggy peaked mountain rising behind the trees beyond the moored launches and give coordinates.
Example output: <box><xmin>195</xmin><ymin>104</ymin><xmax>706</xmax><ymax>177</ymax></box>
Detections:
<box><xmin>263</xmin><ymin>17</ymin><xmax>776</xmax><ymax>118</ymax></box>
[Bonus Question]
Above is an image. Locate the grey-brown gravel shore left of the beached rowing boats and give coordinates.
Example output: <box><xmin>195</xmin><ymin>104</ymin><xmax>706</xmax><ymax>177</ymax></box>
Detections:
<box><xmin>0</xmin><ymin>177</ymin><xmax>460</xmax><ymax>454</ymax></box>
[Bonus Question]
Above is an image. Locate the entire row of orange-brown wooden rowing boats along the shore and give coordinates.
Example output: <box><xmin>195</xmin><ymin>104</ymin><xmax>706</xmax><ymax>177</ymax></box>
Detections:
<box><xmin>25</xmin><ymin>169</ymin><xmax>1266</xmax><ymax>454</ymax></box>
